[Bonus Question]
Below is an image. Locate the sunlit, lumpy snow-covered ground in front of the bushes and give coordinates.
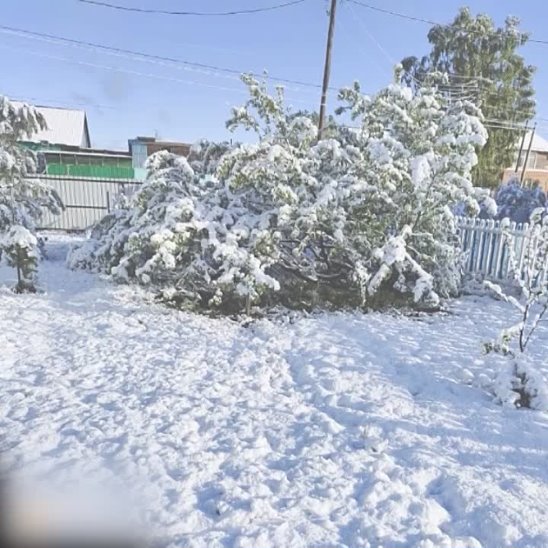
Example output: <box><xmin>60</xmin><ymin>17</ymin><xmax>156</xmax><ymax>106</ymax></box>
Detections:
<box><xmin>0</xmin><ymin>233</ymin><xmax>548</xmax><ymax>548</ymax></box>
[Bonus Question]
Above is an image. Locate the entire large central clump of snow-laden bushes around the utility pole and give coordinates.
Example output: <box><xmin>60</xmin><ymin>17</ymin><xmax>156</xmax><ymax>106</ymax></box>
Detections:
<box><xmin>70</xmin><ymin>76</ymin><xmax>486</xmax><ymax>310</ymax></box>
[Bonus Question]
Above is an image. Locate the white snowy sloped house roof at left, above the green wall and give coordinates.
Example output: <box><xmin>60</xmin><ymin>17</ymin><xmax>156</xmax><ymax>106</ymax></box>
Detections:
<box><xmin>13</xmin><ymin>106</ymin><xmax>91</xmax><ymax>148</ymax></box>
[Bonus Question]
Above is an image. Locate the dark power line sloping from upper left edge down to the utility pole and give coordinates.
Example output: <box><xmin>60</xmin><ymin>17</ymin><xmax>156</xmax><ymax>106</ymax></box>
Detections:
<box><xmin>0</xmin><ymin>25</ymin><xmax>337</xmax><ymax>91</ymax></box>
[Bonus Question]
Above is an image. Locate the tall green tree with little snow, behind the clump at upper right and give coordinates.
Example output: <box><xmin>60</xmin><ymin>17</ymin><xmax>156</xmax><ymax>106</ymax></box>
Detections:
<box><xmin>402</xmin><ymin>8</ymin><xmax>535</xmax><ymax>187</ymax></box>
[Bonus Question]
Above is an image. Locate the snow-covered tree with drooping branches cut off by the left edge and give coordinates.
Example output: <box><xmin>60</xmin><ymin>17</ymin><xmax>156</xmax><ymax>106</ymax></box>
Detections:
<box><xmin>0</xmin><ymin>96</ymin><xmax>62</xmax><ymax>291</ymax></box>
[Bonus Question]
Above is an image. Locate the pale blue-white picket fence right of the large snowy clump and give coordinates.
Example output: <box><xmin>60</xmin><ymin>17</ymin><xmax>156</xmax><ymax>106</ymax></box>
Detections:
<box><xmin>458</xmin><ymin>217</ymin><xmax>548</xmax><ymax>281</ymax></box>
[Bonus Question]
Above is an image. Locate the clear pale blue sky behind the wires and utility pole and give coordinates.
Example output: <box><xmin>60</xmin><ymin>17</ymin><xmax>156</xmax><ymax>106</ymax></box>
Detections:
<box><xmin>4</xmin><ymin>0</ymin><xmax>548</xmax><ymax>148</ymax></box>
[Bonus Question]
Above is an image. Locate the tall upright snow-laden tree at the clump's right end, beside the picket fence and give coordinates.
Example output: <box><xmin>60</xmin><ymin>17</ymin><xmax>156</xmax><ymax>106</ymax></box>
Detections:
<box><xmin>342</xmin><ymin>71</ymin><xmax>487</xmax><ymax>304</ymax></box>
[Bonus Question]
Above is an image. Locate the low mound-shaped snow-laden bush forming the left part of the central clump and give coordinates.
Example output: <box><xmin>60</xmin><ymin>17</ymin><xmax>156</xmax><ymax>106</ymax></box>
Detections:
<box><xmin>69</xmin><ymin>141</ymin><xmax>278</xmax><ymax>310</ymax></box>
